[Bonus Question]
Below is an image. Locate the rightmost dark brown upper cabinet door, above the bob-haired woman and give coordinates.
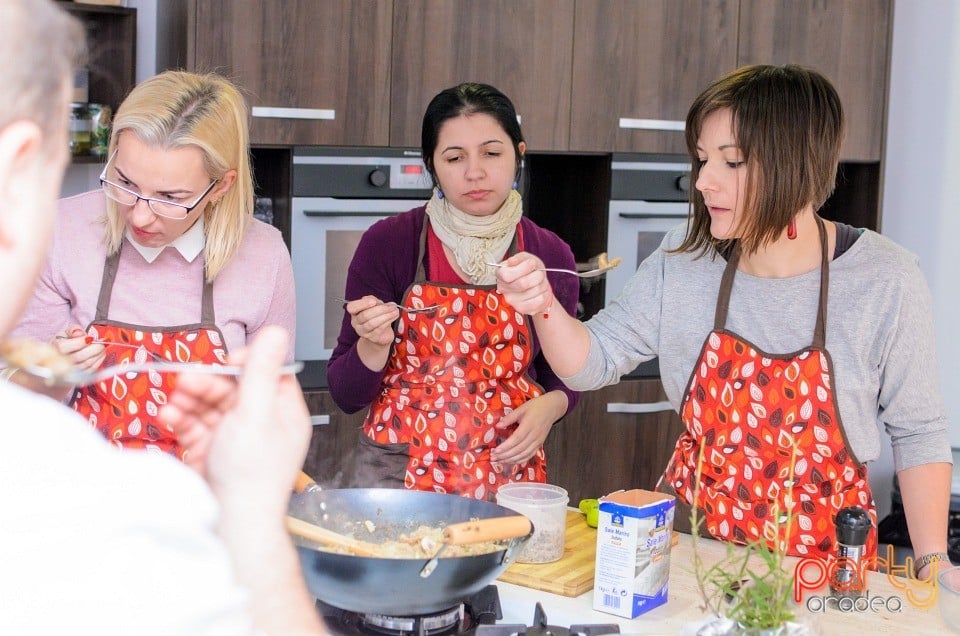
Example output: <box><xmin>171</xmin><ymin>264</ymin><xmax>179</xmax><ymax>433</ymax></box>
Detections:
<box><xmin>738</xmin><ymin>0</ymin><xmax>892</xmax><ymax>161</ymax></box>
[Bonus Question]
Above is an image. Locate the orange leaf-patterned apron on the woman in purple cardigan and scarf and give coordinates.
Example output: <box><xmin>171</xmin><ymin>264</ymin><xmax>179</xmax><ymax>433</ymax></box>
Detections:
<box><xmin>363</xmin><ymin>223</ymin><xmax>546</xmax><ymax>501</ymax></box>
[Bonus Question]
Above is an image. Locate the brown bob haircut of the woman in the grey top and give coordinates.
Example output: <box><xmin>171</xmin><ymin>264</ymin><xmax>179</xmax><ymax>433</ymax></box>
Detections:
<box><xmin>676</xmin><ymin>64</ymin><xmax>844</xmax><ymax>254</ymax></box>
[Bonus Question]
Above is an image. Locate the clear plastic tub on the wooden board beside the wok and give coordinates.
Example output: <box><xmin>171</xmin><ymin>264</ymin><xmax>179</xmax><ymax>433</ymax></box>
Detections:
<box><xmin>497</xmin><ymin>482</ymin><xmax>569</xmax><ymax>563</ymax></box>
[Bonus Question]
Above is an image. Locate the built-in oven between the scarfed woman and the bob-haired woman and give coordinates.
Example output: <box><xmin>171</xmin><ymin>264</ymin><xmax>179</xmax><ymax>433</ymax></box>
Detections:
<box><xmin>605</xmin><ymin>154</ymin><xmax>690</xmax><ymax>303</ymax></box>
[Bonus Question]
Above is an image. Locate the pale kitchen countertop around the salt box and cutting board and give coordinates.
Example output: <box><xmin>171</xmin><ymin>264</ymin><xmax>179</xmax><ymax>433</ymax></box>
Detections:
<box><xmin>496</xmin><ymin>534</ymin><xmax>949</xmax><ymax>636</ymax></box>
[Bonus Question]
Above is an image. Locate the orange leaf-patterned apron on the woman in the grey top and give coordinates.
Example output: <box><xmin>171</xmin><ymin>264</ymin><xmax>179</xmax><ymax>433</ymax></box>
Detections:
<box><xmin>664</xmin><ymin>217</ymin><xmax>877</xmax><ymax>558</ymax></box>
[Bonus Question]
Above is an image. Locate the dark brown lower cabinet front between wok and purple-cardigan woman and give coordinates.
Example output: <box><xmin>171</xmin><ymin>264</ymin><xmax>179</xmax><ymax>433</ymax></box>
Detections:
<box><xmin>303</xmin><ymin>391</ymin><xmax>367</xmax><ymax>488</ymax></box>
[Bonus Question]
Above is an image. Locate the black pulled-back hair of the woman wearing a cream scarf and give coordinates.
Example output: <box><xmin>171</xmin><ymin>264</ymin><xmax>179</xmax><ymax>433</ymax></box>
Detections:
<box><xmin>420</xmin><ymin>82</ymin><xmax>523</xmax><ymax>183</ymax></box>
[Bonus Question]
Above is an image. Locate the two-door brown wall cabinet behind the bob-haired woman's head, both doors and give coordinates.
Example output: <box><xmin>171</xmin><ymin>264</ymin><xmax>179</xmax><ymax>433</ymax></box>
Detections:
<box><xmin>570</xmin><ymin>0</ymin><xmax>892</xmax><ymax>161</ymax></box>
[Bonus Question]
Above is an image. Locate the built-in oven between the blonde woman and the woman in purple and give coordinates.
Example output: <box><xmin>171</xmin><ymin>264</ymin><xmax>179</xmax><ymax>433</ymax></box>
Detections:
<box><xmin>290</xmin><ymin>147</ymin><xmax>430</xmax><ymax>361</ymax></box>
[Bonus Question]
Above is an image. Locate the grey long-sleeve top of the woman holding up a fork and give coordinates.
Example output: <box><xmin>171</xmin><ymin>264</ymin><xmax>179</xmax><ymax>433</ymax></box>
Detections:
<box><xmin>563</xmin><ymin>225</ymin><xmax>952</xmax><ymax>471</ymax></box>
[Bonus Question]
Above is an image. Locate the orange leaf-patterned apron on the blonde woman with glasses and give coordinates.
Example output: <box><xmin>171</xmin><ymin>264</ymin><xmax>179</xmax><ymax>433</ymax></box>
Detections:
<box><xmin>71</xmin><ymin>246</ymin><xmax>227</xmax><ymax>459</ymax></box>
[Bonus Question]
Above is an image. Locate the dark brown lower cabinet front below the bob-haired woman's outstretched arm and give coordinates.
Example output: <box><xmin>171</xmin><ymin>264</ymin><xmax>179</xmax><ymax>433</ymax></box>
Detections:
<box><xmin>544</xmin><ymin>378</ymin><xmax>683</xmax><ymax>506</ymax></box>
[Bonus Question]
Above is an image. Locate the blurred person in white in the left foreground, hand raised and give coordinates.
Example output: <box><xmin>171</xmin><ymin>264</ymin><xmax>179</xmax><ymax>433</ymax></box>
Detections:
<box><xmin>0</xmin><ymin>0</ymin><xmax>323</xmax><ymax>635</ymax></box>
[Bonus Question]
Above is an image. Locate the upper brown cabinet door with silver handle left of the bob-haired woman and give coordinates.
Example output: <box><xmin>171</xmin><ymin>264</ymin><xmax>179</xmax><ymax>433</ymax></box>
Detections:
<box><xmin>570</xmin><ymin>0</ymin><xmax>739</xmax><ymax>152</ymax></box>
